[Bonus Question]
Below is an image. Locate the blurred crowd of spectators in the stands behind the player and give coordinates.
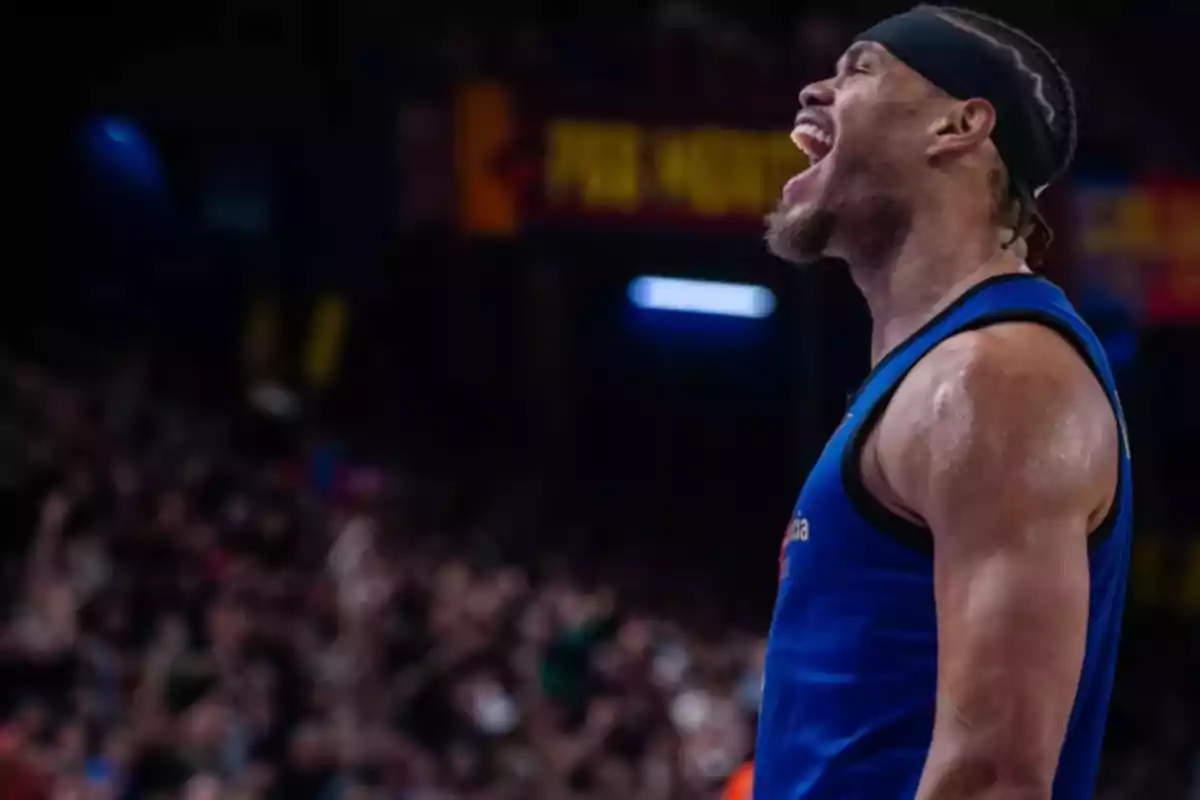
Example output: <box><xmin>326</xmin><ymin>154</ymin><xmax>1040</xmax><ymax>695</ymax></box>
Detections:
<box><xmin>0</xmin><ymin>352</ymin><xmax>1200</xmax><ymax>800</ymax></box>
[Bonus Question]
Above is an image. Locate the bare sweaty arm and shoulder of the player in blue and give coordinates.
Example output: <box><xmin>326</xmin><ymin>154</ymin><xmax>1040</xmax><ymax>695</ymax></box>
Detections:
<box><xmin>876</xmin><ymin>324</ymin><xmax>1117</xmax><ymax>800</ymax></box>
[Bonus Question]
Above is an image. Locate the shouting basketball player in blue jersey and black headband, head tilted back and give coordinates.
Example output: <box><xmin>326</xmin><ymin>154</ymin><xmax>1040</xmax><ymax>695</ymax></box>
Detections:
<box><xmin>754</xmin><ymin>6</ymin><xmax>1130</xmax><ymax>800</ymax></box>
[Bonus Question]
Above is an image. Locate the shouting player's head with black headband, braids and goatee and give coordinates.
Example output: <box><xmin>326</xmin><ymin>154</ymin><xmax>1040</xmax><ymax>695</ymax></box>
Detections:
<box><xmin>767</xmin><ymin>6</ymin><xmax>1075</xmax><ymax>263</ymax></box>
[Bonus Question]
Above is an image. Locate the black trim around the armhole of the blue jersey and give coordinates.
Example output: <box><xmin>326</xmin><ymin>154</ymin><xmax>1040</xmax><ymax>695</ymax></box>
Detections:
<box><xmin>841</xmin><ymin>309</ymin><xmax>1128</xmax><ymax>554</ymax></box>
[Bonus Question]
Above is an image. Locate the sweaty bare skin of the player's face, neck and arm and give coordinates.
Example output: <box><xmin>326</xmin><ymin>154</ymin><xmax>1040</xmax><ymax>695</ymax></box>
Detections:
<box><xmin>767</xmin><ymin>14</ymin><xmax>1121</xmax><ymax>800</ymax></box>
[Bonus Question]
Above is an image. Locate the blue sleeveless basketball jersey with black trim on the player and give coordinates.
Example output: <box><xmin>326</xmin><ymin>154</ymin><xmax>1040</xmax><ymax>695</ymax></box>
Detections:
<box><xmin>754</xmin><ymin>273</ymin><xmax>1132</xmax><ymax>800</ymax></box>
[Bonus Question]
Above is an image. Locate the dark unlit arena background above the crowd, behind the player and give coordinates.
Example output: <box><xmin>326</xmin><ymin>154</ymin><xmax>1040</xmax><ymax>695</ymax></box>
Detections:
<box><xmin>2</xmin><ymin>0</ymin><xmax>1200</xmax><ymax>796</ymax></box>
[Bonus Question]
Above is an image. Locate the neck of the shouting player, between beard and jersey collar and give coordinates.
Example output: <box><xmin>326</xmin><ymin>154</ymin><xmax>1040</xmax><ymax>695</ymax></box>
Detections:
<box><xmin>850</xmin><ymin>215</ymin><xmax>1027</xmax><ymax>365</ymax></box>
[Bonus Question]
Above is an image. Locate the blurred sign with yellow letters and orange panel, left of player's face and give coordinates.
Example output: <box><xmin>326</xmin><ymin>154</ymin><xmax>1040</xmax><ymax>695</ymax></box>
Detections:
<box><xmin>456</xmin><ymin>84</ymin><xmax>806</xmax><ymax>235</ymax></box>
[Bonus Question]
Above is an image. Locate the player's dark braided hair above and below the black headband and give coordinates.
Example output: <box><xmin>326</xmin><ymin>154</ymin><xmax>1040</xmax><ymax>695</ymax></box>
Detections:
<box><xmin>930</xmin><ymin>6</ymin><xmax>1078</xmax><ymax>262</ymax></box>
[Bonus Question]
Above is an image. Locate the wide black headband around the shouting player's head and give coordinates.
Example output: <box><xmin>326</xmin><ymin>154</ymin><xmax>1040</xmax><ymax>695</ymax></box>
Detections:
<box><xmin>854</xmin><ymin>8</ymin><xmax>1069</xmax><ymax>197</ymax></box>
